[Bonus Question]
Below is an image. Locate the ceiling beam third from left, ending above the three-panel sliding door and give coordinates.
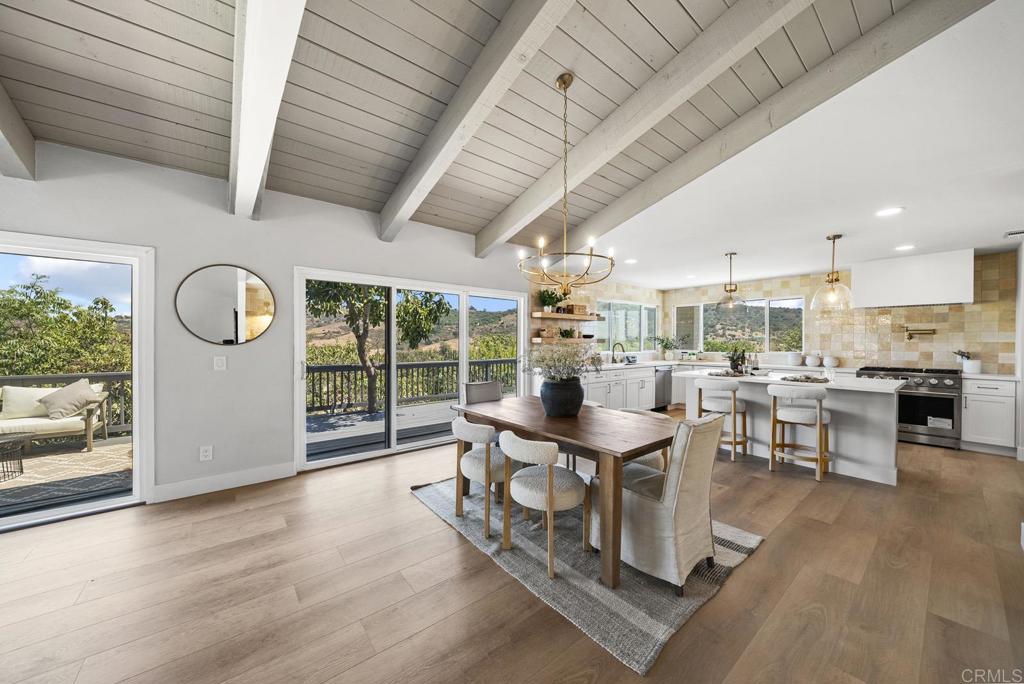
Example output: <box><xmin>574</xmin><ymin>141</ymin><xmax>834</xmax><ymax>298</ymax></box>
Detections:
<box><xmin>379</xmin><ymin>0</ymin><xmax>575</xmax><ymax>242</ymax></box>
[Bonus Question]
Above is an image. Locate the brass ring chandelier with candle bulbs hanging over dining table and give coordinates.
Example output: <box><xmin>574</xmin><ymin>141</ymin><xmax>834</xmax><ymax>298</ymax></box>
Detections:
<box><xmin>518</xmin><ymin>72</ymin><xmax>615</xmax><ymax>297</ymax></box>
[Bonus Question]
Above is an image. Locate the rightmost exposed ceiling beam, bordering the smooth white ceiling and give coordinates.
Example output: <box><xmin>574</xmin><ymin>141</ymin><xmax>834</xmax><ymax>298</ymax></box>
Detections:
<box><xmin>569</xmin><ymin>0</ymin><xmax>992</xmax><ymax>249</ymax></box>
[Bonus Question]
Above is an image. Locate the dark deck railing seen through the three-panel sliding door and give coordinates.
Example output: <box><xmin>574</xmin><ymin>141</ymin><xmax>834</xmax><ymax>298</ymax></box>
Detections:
<box><xmin>306</xmin><ymin>358</ymin><xmax>517</xmax><ymax>414</ymax></box>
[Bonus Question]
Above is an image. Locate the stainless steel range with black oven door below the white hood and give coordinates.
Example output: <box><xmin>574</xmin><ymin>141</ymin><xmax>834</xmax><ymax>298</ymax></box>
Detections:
<box><xmin>857</xmin><ymin>366</ymin><xmax>962</xmax><ymax>448</ymax></box>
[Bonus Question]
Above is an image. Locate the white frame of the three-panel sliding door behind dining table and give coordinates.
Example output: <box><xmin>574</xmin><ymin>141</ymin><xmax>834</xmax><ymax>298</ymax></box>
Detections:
<box><xmin>292</xmin><ymin>266</ymin><xmax>528</xmax><ymax>471</ymax></box>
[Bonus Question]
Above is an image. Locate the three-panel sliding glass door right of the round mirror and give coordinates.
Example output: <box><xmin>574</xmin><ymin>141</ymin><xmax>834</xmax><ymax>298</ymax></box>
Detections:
<box><xmin>296</xmin><ymin>268</ymin><xmax>525</xmax><ymax>468</ymax></box>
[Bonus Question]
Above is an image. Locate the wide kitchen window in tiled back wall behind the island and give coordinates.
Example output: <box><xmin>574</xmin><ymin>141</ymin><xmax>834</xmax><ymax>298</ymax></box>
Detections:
<box><xmin>692</xmin><ymin>297</ymin><xmax>804</xmax><ymax>352</ymax></box>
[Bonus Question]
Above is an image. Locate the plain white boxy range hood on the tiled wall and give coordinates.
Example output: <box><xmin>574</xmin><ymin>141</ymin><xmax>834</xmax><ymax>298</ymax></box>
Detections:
<box><xmin>850</xmin><ymin>250</ymin><xmax>974</xmax><ymax>308</ymax></box>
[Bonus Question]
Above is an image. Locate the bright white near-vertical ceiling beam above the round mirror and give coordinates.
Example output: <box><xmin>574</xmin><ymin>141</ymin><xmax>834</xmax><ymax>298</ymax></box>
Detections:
<box><xmin>227</xmin><ymin>0</ymin><xmax>306</xmax><ymax>218</ymax></box>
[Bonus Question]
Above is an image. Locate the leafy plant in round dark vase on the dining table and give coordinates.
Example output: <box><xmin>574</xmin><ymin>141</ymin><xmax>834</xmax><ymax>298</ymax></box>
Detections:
<box><xmin>526</xmin><ymin>343</ymin><xmax>601</xmax><ymax>418</ymax></box>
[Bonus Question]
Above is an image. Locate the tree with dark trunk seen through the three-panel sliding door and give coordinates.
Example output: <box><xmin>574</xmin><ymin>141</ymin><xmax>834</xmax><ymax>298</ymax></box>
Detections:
<box><xmin>306</xmin><ymin>281</ymin><xmax>452</xmax><ymax>413</ymax></box>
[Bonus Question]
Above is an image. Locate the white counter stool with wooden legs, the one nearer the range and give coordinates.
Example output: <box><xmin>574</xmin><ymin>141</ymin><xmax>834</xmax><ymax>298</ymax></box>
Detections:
<box><xmin>768</xmin><ymin>385</ymin><xmax>831</xmax><ymax>482</ymax></box>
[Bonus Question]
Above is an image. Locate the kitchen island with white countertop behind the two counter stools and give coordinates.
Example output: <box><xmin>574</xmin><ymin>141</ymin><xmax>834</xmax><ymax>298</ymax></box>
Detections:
<box><xmin>673</xmin><ymin>369</ymin><xmax>904</xmax><ymax>485</ymax></box>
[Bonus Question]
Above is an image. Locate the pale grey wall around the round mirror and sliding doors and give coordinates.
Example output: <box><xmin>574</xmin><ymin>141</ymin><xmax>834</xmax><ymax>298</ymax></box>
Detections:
<box><xmin>0</xmin><ymin>143</ymin><xmax>526</xmax><ymax>494</ymax></box>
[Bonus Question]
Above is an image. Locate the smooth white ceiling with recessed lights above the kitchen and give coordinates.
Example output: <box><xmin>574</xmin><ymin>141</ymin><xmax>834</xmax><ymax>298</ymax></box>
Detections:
<box><xmin>599</xmin><ymin>0</ymin><xmax>1024</xmax><ymax>288</ymax></box>
